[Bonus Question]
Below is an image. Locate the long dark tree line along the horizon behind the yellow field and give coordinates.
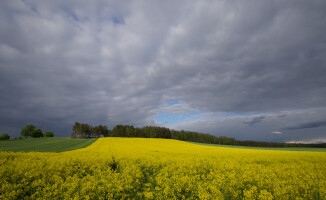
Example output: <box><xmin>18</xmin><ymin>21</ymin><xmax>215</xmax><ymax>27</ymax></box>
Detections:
<box><xmin>72</xmin><ymin>122</ymin><xmax>326</xmax><ymax>148</ymax></box>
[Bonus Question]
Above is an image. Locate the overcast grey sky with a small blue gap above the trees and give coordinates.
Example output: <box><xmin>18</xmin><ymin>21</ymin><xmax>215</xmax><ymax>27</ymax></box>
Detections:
<box><xmin>0</xmin><ymin>0</ymin><xmax>326</xmax><ymax>142</ymax></box>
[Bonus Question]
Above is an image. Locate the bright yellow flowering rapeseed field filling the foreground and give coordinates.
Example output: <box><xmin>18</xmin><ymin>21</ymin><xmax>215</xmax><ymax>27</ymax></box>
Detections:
<box><xmin>0</xmin><ymin>138</ymin><xmax>326</xmax><ymax>199</ymax></box>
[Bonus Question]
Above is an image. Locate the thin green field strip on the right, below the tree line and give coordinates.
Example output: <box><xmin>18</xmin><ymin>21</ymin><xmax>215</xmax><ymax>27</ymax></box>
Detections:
<box><xmin>190</xmin><ymin>142</ymin><xmax>326</xmax><ymax>152</ymax></box>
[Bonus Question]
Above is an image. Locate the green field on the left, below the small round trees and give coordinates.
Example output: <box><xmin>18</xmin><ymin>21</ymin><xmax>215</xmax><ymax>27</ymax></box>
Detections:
<box><xmin>0</xmin><ymin>137</ymin><xmax>96</xmax><ymax>152</ymax></box>
